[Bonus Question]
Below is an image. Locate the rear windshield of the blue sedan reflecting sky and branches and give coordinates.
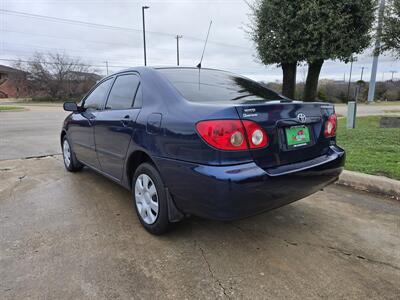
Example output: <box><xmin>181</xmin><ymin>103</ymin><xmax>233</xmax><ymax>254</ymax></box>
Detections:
<box><xmin>158</xmin><ymin>68</ymin><xmax>283</xmax><ymax>103</ymax></box>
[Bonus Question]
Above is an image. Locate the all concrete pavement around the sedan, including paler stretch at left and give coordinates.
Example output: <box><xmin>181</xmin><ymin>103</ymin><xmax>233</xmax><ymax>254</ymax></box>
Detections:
<box><xmin>0</xmin><ymin>107</ymin><xmax>400</xmax><ymax>299</ymax></box>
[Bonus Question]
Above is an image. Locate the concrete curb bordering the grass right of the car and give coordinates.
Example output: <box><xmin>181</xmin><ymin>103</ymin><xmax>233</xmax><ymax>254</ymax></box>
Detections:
<box><xmin>337</xmin><ymin>170</ymin><xmax>400</xmax><ymax>200</ymax></box>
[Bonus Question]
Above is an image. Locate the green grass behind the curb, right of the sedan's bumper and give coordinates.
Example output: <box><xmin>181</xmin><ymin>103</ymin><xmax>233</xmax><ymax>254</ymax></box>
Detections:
<box><xmin>337</xmin><ymin>116</ymin><xmax>400</xmax><ymax>180</ymax></box>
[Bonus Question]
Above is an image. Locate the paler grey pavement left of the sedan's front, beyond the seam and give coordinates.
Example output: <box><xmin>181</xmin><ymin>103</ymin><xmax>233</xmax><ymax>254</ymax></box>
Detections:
<box><xmin>0</xmin><ymin>106</ymin><xmax>68</xmax><ymax>160</ymax></box>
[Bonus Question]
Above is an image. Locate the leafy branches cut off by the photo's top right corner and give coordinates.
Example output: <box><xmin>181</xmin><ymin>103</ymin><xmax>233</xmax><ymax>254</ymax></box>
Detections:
<box><xmin>381</xmin><ymin>0</ymin><xmax>400</xmax><ymax>59</ymax></box>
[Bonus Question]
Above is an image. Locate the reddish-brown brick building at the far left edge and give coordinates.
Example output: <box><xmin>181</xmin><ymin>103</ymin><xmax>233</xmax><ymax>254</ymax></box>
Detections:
<box><xmin>0</xmin><ymin>65</ymin><xmax>30</xmax><ymax>98</ymax></box>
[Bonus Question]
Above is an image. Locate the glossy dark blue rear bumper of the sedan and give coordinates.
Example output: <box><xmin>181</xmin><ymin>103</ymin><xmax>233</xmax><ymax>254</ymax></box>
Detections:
<box><xmin>155</xmin><ymin>146</ymin><xmax>345</xmax><ymax>220</ymax></box>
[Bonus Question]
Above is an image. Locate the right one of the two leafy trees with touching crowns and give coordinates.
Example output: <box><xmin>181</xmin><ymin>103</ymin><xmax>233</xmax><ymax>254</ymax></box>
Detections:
<box><xmin>298</xmin><ymin>0</ymin><xmax>376</xmax><ymax>101</ymax></box>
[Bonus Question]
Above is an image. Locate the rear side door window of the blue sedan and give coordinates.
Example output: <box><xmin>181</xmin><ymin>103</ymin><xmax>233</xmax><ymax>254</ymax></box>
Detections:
<box><xmin>106</xmin><ymin>74</ymin><xmax>140</xmax><ymax>110</ymax></box>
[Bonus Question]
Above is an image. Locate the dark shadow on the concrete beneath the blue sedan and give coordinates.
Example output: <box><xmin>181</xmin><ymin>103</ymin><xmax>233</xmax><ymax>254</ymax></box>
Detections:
<box><xmin>81</xmin><ymin>168</ymin><xmax>323</xmax><ymax>243</ymax></box>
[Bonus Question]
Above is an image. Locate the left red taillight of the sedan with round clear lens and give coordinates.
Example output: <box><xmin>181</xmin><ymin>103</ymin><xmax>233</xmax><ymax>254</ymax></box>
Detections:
<box><xmin>196</xmin><ymin>120</ymin><xmax>268</xmax><ymax>150</ymax></box>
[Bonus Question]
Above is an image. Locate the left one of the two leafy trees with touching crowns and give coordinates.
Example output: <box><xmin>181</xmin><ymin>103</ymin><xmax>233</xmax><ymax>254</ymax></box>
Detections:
<box><xmin>249</xmin><ymin>0</ymin><xmax>304</xmax><ymax>98</ymax></box>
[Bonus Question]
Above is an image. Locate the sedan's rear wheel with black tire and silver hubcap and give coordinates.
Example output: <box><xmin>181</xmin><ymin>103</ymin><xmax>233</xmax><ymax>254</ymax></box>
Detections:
<box><xmin>132</xmin><ymin>163</ymin><xmax>171</xmax><ymax>235</ymax></box>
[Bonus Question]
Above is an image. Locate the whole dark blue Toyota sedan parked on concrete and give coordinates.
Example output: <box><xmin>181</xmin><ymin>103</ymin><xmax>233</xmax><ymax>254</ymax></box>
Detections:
<box><xmin>61</xmin><ymin>67</ymin><xmax>345</xmax><ymax>234</ymax></box>
